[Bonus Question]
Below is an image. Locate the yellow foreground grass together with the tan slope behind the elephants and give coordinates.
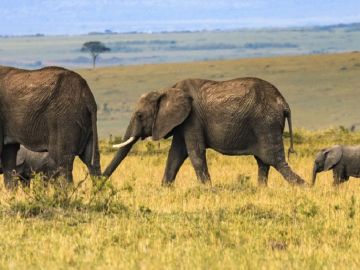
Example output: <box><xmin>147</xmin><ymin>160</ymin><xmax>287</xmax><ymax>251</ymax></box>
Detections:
<box><xmin>0</xmin><ymin>52</ymin><xmax>360</xmax><ymax>269</ymax></box>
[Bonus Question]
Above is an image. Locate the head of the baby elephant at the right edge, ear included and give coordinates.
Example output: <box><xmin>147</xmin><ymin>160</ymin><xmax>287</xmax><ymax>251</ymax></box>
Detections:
<box><xmin>312</xmin><ymin>145</ymin><xmax>342</xmax><ymax>185</ymax></box>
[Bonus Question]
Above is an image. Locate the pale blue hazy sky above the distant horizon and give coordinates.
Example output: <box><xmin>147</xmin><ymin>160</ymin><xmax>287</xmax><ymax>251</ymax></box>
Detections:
<box><xmin>0</xmin><ymin>0</ymin><xmax>360</xmax><ymax>35</ymax></box>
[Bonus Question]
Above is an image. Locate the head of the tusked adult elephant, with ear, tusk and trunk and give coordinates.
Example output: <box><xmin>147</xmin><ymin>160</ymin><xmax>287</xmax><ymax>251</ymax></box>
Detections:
<box><xmin>103</xmin><ymin>88</ymin><xmax>192</xmax><ymax>177</ymax></box>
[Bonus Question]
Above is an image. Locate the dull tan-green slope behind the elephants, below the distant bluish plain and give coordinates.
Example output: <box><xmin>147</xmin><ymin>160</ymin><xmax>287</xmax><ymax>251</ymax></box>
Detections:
<box><xmin>78</xmin><ymin>52</ymin><xmax>360</xmax><ymax>138</ymax></box>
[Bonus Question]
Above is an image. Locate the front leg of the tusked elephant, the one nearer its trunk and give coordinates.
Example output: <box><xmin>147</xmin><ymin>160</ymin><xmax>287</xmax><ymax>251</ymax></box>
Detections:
<box><xmin>162</xmin><ymin>134</ymin><xmax>188</xmax><ymax>186</ymax></box>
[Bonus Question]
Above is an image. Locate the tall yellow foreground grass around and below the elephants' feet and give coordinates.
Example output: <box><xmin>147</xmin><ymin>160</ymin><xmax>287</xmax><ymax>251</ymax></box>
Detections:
<box><xmin>0</xmin><ymin>128</ymin><xmax>360</xmax><ymax>269</ymax></box>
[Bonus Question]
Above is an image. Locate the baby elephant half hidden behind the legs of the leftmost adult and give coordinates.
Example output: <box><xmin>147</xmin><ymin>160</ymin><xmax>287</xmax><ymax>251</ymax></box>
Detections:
<box><xmin>0</xmin><ymin>145</ymin><xmax>51</xmax><ymax>186</ymax></box>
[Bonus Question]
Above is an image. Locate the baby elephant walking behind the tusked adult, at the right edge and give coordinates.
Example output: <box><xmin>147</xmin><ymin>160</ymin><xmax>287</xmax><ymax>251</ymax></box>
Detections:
<box><xmin>312</xmin><ymin>145</ymin><xmax>360</xmax><ymax>185</ymax></box>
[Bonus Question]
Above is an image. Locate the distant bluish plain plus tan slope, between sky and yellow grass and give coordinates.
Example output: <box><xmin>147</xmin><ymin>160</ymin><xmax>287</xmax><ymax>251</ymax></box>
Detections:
<box><xmin>0</xmin><ymin>28</ymin><xmax>360</xmax><ymax>138</ymax></box>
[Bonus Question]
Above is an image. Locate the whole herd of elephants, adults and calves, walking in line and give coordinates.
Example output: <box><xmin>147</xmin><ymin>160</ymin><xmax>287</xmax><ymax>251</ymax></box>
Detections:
<box><xmin>0</xmin><ymin>66</ymin><xmax>360</xmax><ymax>189</ymax></box>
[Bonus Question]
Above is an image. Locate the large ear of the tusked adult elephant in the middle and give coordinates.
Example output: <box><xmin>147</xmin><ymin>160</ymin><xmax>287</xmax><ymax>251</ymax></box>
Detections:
<box><xmin>152</xmin><ymin>88</ymin><xmax>192</xmax><ymax>140</ymax></box>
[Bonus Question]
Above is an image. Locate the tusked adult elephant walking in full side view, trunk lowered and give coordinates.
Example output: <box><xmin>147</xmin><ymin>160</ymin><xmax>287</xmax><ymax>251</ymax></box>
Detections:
<box><xmin>104</xmin><ymin>78</ymin><xmax>304</xmax><ymax>184</ymax></box>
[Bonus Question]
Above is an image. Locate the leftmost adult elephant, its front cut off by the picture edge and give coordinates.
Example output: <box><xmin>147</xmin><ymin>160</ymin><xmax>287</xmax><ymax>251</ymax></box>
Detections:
<box><xmin>0</xmin><ymin>66</ymin><xmax>101</xmax><ymax>188</ymax></box>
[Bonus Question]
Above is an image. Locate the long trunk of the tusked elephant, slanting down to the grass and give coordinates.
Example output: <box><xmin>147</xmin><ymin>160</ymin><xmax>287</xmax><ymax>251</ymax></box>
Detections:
<box><xmin>103</xmin><ymin>122</ymin><xmax>139</xmax><ymax>178</ymax></box>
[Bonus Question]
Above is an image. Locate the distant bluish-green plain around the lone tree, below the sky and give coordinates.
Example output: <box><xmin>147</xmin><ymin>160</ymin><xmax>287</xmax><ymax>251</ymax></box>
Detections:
<box><xmin>0</xmin><ymin>24</ymin><xmax>360</xmax><ymax>68</ymax></box>
